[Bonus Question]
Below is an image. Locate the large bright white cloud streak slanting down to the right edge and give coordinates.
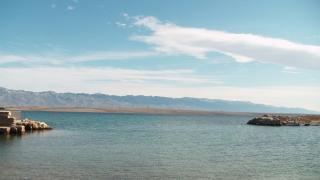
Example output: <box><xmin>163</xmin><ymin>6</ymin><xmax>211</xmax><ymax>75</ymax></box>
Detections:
<box><xmin>131</xmin><ymin>16</ymin><xmax>320</xmax><ymax>68</ymax></box>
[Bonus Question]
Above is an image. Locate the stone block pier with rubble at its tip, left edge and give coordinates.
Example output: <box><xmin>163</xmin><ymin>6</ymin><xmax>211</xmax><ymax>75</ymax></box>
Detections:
<box><xmin>0</xmin><ymin>108</ymin><xmax>52</xmax><ymax>135</ymax></box>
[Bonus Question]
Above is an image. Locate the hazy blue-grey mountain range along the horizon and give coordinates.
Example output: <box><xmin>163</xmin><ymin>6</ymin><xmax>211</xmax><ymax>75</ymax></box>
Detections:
<box><xmin>0</xmin><ymin>87</ymin><xmax>317</xmax><ymax>113</ymax></box>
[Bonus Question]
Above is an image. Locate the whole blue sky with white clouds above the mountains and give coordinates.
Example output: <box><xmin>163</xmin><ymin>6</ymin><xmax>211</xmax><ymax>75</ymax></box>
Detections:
<box><xmin>0</xmin><ymin>0</ymin><xmax>320</xmax><ymax>111</ymax></box>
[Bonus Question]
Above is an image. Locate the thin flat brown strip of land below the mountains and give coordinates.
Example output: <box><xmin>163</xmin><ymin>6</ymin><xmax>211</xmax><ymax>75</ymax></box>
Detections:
<box><xmin>7</xmin><ymin>106</ymin><xmax>310</xmax><ymax>116</ymax></box>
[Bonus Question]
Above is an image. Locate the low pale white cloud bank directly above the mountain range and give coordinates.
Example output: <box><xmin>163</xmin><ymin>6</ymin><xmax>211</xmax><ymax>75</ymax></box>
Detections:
<box><xmin>0</xmin><ymin>67</ymin><xmax>320</xmax><ymax>111</ymax></box>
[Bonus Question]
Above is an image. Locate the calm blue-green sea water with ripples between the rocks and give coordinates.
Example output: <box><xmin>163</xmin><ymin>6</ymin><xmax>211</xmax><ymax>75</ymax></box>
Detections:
<box><xmin>0</xmin><ymin>112</ymin><xmax>320</xmax><ymax>180</ymax></box>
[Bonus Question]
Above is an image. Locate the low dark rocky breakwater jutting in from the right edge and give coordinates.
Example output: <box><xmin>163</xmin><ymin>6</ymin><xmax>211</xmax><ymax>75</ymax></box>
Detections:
<box><xmin>247</xmin><ymin>114</ymin><xmax>320</xmax><ymax>126</ymax></box>
